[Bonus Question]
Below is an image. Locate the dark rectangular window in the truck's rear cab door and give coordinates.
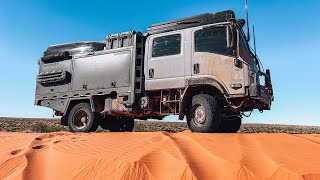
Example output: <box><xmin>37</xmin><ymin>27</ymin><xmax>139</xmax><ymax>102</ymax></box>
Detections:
<box><xmin>152</xmin><ymin>34</ymin><xmax>181</xmax><ymax>57</ymax></box>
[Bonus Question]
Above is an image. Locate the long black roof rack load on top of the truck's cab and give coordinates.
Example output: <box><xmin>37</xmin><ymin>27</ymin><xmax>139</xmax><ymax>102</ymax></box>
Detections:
<box><xmin>148</xmin><ymin>10</ymin><xmax>235</xmax><ymax>34</ymax></box>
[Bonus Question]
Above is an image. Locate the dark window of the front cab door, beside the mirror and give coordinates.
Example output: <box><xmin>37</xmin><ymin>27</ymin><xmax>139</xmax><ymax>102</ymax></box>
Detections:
<box><xmin>195</xmin><ymin>27</ymin><xmax>234</xmax><ymax>56</ymax></box>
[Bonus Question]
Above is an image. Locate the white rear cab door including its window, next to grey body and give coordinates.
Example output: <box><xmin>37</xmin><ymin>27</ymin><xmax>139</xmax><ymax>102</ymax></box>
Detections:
<box><xmin>145</xmin><ymin>31</ymin><xmax>185</xmax><ymax>90</ymax></box>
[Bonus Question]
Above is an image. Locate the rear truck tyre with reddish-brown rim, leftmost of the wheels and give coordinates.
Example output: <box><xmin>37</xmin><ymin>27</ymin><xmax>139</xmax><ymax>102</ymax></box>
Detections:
<box><xmin>68</xmin><ymin>103</ymin><xmax>100</xmax><ymax>132</ymax></box>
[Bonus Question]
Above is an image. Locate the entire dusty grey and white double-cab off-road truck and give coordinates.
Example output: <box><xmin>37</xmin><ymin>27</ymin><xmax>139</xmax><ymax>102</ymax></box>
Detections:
<box><xmin>35</xmin><ymin>11</ymin><xmax>273</xmax><ymax>132</ymax></box>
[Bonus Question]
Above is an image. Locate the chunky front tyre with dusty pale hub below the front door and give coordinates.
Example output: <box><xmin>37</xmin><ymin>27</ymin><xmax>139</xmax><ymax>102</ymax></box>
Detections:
<box><xmin>187</xmin><ymin>94</ymin><xmax>221</xmax><ymax>133</ymax></box>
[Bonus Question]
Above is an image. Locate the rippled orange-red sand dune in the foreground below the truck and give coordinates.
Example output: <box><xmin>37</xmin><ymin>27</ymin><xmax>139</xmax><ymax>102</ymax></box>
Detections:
<box><xmin>0</xmin><ymin>131</ymin><xmax>320</xmax><ymax>180</ymax></box>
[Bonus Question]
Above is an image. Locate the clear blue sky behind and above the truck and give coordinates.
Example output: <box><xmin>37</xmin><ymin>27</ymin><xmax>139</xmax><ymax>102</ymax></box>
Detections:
<box><xmin>0</xmin><ymin>0</ymin><xmax>320</xmax><ymax>126</ymax></box>
